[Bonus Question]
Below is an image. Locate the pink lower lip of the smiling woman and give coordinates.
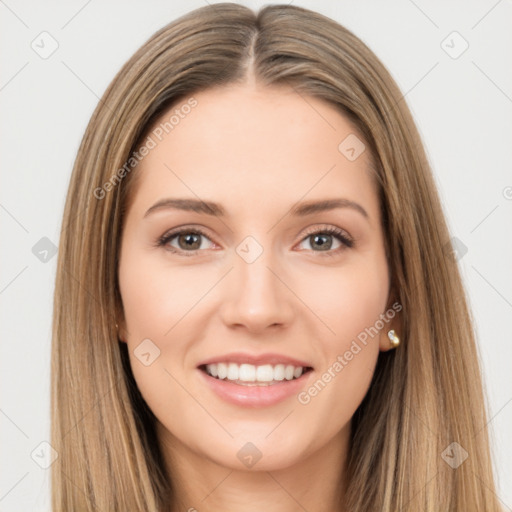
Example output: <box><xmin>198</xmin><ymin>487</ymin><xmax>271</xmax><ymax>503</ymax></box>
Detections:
<box><xmin>198</xmin><ymin>369</ymin><xmax>312</xmax><ymax>407</ymax></box>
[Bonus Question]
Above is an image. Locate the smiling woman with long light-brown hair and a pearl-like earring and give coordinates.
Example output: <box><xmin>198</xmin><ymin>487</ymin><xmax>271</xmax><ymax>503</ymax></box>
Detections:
<box><xmin>52</xmin><ymin>3</ymin><xmax>500</xmax><ymax>512</ymax></box>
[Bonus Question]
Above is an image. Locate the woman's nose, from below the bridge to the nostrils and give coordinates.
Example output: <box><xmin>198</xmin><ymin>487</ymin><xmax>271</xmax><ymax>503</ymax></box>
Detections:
<box><xmin>220</xmin><ymin>245</ymin><xmax>294</xmax><ymax>334</ymax></box>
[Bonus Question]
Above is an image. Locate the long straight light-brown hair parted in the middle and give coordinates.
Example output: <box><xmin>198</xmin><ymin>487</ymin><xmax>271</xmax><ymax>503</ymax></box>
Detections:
<box><xmin>51</xmin><ymin>3</ymin><xmax>501</xmax><ymax>512</ymax></box>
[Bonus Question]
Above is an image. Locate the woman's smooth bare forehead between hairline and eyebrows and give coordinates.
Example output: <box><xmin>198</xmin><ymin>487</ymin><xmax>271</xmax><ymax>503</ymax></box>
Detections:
<box><xmin>126</xmin><ymin>85</ymin><xmax>378</xmax><ymax>221</ymax></box>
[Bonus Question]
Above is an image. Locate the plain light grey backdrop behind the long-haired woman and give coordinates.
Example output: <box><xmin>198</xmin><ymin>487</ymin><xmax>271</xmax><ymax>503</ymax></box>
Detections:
<box><xmin>0</xmin><ymin>0</ymin><xmax>512</xmax><ymax>512</ymax></box>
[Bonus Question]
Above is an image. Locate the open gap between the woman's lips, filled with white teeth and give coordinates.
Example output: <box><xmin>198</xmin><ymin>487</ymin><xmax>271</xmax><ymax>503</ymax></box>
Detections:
<box><xmin>199</xmin><ymin>363</ymin><xmax>312</xmax><ymax>386</ymax></box>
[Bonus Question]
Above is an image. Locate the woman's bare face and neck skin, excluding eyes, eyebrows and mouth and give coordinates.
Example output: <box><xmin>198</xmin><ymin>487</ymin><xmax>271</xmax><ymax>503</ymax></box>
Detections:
<box><xmin>119</xmin><ymin>82</ymin><xmax>397</xmax><ymax>512</ymax></box>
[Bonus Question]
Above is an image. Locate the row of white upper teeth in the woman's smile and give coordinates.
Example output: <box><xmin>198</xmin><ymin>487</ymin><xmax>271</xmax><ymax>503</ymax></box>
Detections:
<box><xmin>206</xmin><ymin>363</ymin><xmax>304</xmax><ymax>382</ymax></box>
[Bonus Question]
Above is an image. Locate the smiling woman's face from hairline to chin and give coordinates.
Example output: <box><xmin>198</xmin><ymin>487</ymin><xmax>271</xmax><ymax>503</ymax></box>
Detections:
<box><xmin>119</xmin><ymin>85</ymin><xmax>394</xmax><ymax>470</ymax></box>
